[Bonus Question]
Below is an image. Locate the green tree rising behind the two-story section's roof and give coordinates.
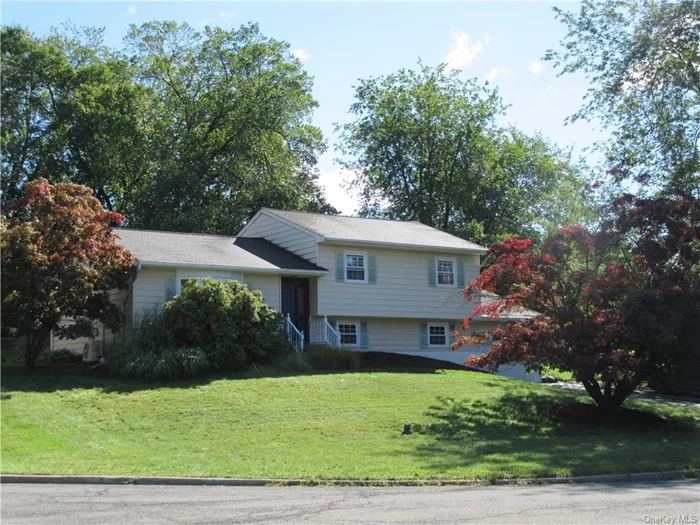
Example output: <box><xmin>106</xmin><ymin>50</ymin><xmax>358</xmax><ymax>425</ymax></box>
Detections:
<box><xmin>339</xmin><ymin>64</ymin><xmax>588</xmax><ymax>242</ymax></box>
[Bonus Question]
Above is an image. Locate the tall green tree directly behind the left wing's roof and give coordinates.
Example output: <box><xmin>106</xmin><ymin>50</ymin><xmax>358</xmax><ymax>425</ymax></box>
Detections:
<box><xmin>126</xmin><ymin>22</ymin><xmax>334</xmax><ymax>233</ymax></box>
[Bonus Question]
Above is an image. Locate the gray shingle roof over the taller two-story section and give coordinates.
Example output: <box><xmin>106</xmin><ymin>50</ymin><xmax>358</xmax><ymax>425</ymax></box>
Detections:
<box><xmin>263</xmin><ymin>208</ymin><xmax>486</xmax><ymax>253</ymax></box>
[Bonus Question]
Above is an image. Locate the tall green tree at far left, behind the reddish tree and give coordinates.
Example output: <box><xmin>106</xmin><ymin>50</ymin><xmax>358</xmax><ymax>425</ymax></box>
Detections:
<box><xmin>0</xmin><ymin>26</ymin><xmax>147</xmax><ymax>209</ymax></box>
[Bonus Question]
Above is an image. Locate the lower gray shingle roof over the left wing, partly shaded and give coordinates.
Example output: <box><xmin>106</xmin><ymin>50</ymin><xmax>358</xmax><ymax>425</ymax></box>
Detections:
<box><xmin>114</xmin><ymin>228</ymin><xmax>326</xmax><ymax>272</ymax></box>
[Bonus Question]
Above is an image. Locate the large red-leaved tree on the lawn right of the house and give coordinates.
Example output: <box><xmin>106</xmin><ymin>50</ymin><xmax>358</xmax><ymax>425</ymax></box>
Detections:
<box><xmin>454</xmin><ymin>195</ymin><xmax>700</xmax><ymax>410</ymax></box>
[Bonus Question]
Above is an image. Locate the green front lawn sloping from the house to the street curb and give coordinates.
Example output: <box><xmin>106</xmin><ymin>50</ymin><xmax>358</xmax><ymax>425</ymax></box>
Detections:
<box><xmin>0</xmin><ymin>364</ymin><xmax>700</xmax><ymax>479</ymax></box>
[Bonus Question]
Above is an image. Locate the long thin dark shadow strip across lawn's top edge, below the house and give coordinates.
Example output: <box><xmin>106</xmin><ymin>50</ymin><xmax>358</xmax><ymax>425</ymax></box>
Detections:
<box><xmin>2</xmin><ymin>352</ymin><xmax>495</xmax><ymax>392</ymax></box>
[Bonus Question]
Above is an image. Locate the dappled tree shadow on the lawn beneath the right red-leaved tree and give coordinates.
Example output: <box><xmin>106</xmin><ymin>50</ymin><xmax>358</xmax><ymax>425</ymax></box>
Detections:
<box><xmin>404</xmin><ymin>387</ymin><xmax>700</xmax><ymax>478</ymax></box>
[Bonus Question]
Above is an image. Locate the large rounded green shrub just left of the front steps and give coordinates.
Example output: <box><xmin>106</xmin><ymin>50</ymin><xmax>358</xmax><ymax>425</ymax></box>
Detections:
<box><xmin>165</xmin><ymin>278</ymin><xmax>288</xmax><ymax>371</ymax></box>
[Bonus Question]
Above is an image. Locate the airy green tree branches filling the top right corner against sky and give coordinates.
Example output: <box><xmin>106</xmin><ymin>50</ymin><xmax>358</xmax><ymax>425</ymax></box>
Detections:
<box><xmin>545</xmin><ymin>0</ymin><xmax>700</xmax><ymax>195</ymax></box>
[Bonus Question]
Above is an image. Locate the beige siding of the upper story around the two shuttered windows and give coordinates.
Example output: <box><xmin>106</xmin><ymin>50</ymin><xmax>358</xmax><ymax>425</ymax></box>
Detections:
<box><xmin>317</xmin><ymin>244</ymin><xmax>479</xmax><ymax>319</ymax></box>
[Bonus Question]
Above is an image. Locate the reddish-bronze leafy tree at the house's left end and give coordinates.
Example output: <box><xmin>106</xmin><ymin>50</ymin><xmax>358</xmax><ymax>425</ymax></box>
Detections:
<box><xmin>1</xmin><ymin>179</ymin><xmax>135</xmax><ymax>368</ymax></box>
